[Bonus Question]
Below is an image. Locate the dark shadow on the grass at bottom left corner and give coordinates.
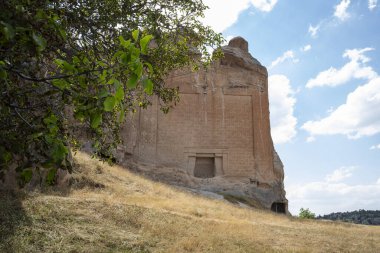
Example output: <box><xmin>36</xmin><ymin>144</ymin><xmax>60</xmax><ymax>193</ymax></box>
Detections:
<box><xmin>0</xmin><ymin>189</ymin><xmax>31</xmax><ymax>252</ymax></box>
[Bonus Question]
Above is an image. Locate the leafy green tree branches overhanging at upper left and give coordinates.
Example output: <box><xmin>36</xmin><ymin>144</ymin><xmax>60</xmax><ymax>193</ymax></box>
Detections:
<box><xmin>0</xmin><ymin>0</ymin><xmax>222</xmax><ymax>186</ymax></box>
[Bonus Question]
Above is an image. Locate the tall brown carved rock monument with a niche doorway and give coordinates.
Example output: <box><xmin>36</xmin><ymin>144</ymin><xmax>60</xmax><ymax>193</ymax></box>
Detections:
<box><xmin>122</xmin><ymin>37</ymin><xmax>287</xmax><ymax>213</ymax></box>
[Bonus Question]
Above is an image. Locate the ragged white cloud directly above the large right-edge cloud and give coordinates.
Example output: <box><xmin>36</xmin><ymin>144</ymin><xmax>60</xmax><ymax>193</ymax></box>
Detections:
<box><xmin>306</xmin><ymin>47</ymin><xmax>377</xmax><ymax>88</ymax></box>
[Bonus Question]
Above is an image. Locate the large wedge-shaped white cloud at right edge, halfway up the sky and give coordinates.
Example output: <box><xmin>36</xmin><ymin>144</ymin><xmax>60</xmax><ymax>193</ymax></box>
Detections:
<box><xmin>302</xmin><ymin>77</ymin><xmax>380</xmax><ymax>139</ymax></box>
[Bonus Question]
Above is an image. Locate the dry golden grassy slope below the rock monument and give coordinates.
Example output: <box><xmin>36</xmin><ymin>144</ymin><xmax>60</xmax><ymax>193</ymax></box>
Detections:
<box><xmin>0</xmin><ymin>154</ymin><xmax>380</xmax><ymax>252</ymax></box>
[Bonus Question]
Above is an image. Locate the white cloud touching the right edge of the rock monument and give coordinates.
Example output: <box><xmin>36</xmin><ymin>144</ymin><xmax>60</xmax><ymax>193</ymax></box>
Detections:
<box><xmin>268</xmin><ymin>75</ymin><xmax>297</xmax><ymax>144</ymax></box>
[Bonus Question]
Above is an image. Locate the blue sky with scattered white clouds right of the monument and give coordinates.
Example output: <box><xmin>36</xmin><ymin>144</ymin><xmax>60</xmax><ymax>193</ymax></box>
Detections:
<box><xmin>203</xmin><ymin>0</ymin><xmax>380</xmax><ymax>215</ymax></box>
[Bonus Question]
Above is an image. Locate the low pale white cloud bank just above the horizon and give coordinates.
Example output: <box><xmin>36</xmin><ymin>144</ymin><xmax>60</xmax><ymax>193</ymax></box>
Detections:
<box><xmin>286</xmin><ymin>171</ymin><xmax>380</xmax><ymax>214</ymax></box>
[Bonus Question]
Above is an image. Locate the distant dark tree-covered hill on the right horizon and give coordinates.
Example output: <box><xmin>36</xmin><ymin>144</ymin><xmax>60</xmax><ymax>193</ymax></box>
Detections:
<box><xmin>317</xmin><ymin>209</ymin><xmax>380</xmax><ymax>226</ymax></box>
